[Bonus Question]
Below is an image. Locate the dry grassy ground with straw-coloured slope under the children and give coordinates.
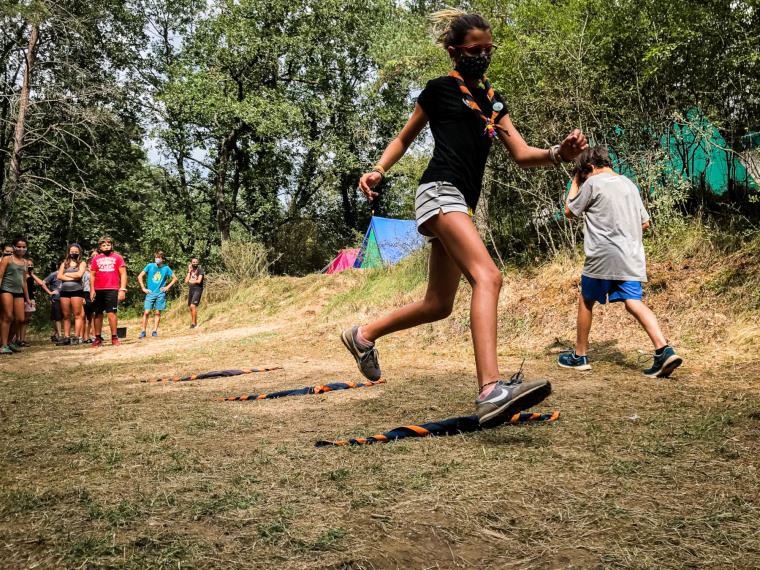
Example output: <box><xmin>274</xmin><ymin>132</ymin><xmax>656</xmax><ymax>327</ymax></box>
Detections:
<box><xmin>0</xmin><ymin>229</ymin><xmax>760</xmax><ymax>569</ymax></box>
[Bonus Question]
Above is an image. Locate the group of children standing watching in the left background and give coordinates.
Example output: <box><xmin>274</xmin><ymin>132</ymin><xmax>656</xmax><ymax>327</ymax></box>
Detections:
<box><xmin>0</xmin><ymin>236</ymin><xmax>205</xmax><ymax>355</ymax></box>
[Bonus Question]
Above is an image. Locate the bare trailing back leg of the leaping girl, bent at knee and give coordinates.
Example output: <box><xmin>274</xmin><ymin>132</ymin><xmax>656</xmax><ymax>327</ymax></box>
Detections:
<box><xmin>362</xmin><ymin>240</ymin><xmax>462</xmax><ymax>341</ymax></box>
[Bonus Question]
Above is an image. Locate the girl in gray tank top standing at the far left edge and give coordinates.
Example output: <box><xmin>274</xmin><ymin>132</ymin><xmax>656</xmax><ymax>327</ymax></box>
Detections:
<box><xmin>0</xmin><ymin>238</ymin><xmax>29</xmax><ymax>355</ymax></box>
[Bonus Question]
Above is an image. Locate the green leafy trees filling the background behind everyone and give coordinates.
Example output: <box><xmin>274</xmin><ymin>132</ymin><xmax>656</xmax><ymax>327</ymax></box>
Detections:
<box><xmin>0</xmin><ymin>0</ymin><xmax>760</xmax><ymax>275</ymax></box>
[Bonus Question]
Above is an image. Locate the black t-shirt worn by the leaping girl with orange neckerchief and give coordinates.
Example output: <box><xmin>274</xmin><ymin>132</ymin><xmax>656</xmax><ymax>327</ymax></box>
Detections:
<box><xmin>417</xmin><ymin>76</ymin><xmax>509</xmax><ymax>210</ymax></box>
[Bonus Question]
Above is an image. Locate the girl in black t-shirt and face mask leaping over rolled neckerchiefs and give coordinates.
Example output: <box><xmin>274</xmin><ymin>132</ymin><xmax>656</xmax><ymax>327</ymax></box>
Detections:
<box><xmin>341</xmin><ymin>10</ymin><xmax>588</xmax><ymax>427</ymax></box>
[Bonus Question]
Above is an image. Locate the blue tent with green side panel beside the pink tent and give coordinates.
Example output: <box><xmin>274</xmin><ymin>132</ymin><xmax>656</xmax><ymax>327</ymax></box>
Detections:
<box><xmin>354</xmin><ymin>216</ymin><xmax>425</xmax><ymax>269</ymax></box>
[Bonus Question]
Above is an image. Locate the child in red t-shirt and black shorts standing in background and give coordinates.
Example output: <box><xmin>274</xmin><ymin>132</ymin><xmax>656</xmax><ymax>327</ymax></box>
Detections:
<box><xmin>90</xmin><ymin>236</ymin><xmax>127</xmax><ymax>348</ymax></box>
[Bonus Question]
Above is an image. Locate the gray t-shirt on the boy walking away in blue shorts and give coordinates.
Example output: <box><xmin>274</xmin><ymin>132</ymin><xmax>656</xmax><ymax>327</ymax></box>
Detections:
<box><xmin>568</xmin><ymin>172</ymin><xmax>649</xmax><ymax>281</ymax></box>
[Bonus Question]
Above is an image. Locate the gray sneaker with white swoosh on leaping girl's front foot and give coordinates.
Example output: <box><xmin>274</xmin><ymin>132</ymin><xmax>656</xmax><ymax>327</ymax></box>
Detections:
<box><xmin>475</xmin><ymin>374</ymin><xmax>552</xmax><ymax>428</ymax></box>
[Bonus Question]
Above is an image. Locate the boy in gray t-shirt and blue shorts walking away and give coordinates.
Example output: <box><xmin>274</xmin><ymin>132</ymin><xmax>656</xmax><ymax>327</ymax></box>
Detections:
<box><xmin>559</xmin><ymin>146</ymin><xmax>683</xmax><ymax>378</ymax></box>
